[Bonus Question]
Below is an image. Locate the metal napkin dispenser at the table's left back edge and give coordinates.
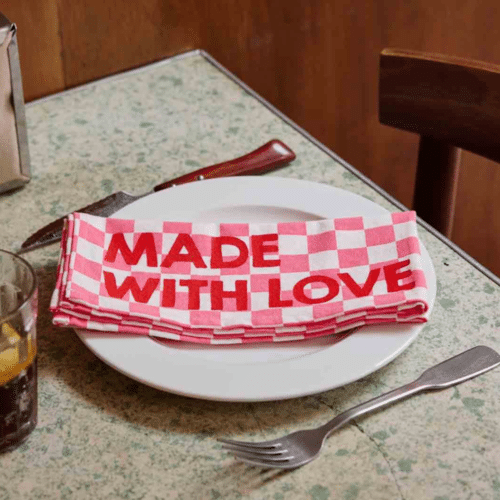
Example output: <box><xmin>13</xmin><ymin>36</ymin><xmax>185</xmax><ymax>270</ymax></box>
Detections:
<box><xmin>0</xmin><ymin>13</ymin><xmax>30</xmax><ymax>193</ymax></box>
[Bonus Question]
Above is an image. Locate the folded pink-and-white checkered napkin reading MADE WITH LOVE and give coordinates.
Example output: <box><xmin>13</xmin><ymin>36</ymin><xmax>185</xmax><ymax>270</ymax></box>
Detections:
<box><xmin>51</xmin><ymin>212</ymin><xmax>428</xmax><ymax>344</ymax></box>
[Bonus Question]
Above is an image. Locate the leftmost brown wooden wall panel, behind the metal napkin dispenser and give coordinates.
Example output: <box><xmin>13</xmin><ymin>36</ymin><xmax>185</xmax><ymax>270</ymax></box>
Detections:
<box><xmin>0</xmin><ymin>0</ymin><xmax>65</xmax><ymax>101</ymax></box>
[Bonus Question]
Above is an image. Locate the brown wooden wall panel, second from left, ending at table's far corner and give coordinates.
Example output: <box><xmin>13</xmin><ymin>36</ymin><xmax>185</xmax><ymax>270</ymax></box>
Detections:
<box><xmin>59</xmin><ymin>0</ymin><xmax>203</xmax><ymax>87</ymax></box>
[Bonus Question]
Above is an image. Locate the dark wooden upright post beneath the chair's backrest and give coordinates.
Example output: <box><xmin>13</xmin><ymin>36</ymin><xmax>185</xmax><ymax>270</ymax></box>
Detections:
<box><xmin>413</xmin><ymin>136</ymin><xmax>461</xmax><ymax>238</ymax></box>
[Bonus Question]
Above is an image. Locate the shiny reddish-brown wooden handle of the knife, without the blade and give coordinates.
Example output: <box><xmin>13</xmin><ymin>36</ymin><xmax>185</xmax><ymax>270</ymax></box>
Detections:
<box><xmin>153</xmin><ymin>139</ymin><xmax>295</xmax><ymax>191</ymax></box>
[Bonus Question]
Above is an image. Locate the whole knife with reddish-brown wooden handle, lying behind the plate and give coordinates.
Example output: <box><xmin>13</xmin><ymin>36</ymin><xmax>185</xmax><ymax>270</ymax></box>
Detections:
<box><xmin>17</xmin><ymin>139</ymin><xmax>295</xmax><ymax>254</ymax></box>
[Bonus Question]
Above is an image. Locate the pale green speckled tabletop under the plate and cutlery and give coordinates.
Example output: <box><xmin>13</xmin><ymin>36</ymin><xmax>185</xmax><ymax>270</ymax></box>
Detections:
<box><xmin>0</xmin><ymin>54</ymin><xmax>500</xmax><ymax>500</ymax></box>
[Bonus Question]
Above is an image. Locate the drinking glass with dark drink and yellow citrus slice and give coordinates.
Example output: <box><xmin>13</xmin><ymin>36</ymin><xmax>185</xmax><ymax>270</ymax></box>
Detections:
<box><xmin>0</xmin><ymin>250</ymin><xmax>38</xmax><ymax>453</ymax></box>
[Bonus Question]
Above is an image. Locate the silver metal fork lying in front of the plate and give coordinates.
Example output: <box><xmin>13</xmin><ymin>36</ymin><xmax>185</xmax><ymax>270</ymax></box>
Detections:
<box><xmin>218</xmin><ymin>346</ymin><xmax>500</xmax><ymax>469</ymax></box>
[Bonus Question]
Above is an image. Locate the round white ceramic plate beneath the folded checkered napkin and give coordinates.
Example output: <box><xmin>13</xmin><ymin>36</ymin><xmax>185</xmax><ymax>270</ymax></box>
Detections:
<box><xmin>77</xmin><ymin>177</ymin><xmax>436</xmax><ymax>401</ymax></box>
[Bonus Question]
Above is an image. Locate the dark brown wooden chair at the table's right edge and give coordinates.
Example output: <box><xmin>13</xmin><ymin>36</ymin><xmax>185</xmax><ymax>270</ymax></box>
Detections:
<box><xmin>379</xmin><ymin>49</ymin><xmax>500</xmax><ymax>237</ymax></box>
